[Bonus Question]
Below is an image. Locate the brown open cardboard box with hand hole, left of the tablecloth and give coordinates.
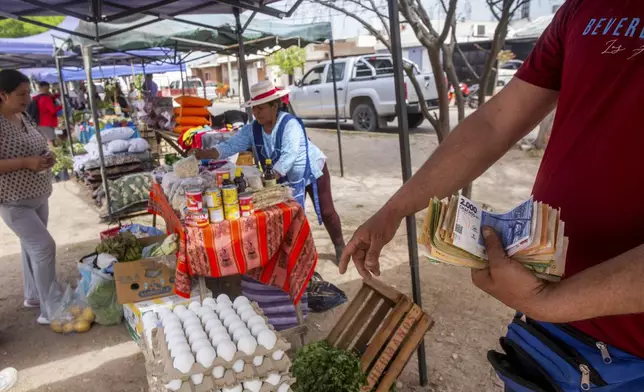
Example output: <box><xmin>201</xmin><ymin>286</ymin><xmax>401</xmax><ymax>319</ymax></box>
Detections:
<box><xmin>114</xmin><ymin>236</ymin><xmax>176</xmax><ymax>305</ymax></box>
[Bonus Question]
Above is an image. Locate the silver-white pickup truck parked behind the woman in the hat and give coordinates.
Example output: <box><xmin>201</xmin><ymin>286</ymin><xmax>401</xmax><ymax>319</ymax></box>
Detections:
<box><xmin>289</xmin><ymin>54</ymin><xmax>438</xmax><ymax>131</ymax></box>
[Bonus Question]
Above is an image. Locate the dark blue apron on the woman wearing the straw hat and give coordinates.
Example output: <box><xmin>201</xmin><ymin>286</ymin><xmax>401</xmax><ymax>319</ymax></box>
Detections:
<box><xmin>253</xmin><ymin>114</ymin><xmax>322</xmax><ymax>224</ymax></box>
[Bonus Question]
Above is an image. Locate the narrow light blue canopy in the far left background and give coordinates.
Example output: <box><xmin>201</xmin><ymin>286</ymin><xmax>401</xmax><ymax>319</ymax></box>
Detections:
<box><xmin>23</xmin><ymin>64</ymin><xmax>186</xmax><ymax>83</ymax></box>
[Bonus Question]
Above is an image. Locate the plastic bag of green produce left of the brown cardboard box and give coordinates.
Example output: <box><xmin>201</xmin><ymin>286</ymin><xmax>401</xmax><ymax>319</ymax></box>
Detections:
<box><xmin>87</xmin><ymin>269</ymin><xmax>123</xmax><ymax>325</ymax></box>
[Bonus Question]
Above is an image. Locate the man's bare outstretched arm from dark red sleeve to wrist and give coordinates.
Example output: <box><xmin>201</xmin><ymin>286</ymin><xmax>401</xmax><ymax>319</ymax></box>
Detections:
<box><xmin>385</xmin><ymin>80</ymin><xmax>557</xmax><ymax>217</ymax></box>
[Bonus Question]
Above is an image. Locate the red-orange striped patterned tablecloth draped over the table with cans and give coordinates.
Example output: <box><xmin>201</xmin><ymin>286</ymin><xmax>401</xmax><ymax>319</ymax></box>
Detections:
<box><xmin>149</xmin><ymin>183</ymin><xmax>317</xmax><ymax>304</ymax></box>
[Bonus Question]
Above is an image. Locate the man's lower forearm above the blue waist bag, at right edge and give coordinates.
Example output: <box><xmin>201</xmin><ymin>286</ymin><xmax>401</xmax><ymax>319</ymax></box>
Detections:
<box><xmin>533</xmin><ymin>245</ymin><xmax>644</xmax><ymax>323</ymax></box>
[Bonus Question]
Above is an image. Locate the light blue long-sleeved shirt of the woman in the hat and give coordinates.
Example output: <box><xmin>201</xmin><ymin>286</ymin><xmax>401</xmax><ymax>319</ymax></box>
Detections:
<box><xmin>214</xmin><ymin>112</ymin><xmax>326</xmax><ymax>185</ymax></box>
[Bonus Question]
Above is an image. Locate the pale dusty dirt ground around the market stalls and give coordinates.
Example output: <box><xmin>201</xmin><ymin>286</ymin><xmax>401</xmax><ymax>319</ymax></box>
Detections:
<box><xmin>0</xmin><ymin>126</ymin><xmax>539</xmax><ymax>392</ymax></box>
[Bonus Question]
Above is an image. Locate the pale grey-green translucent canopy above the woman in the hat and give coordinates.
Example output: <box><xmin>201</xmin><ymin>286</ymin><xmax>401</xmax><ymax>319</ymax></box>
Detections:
<box><xmin>72</xmin><ymin>15</ymin><xmax>332</xmax><ymax>53</ymax></box>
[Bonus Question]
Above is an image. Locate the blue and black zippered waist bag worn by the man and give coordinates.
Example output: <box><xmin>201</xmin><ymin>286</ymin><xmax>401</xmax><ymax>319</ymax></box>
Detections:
<box><xmin>487</xmin><ymin>313</ymin><xmax>644</xmax><ymax>392</ymax></box>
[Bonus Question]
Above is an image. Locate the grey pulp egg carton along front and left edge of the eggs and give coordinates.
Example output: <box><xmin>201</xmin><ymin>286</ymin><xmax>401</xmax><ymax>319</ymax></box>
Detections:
<box><xmin>154</xmin><ymin>327</ymin><xmax>291</xmax><ymax>387</ymax></box>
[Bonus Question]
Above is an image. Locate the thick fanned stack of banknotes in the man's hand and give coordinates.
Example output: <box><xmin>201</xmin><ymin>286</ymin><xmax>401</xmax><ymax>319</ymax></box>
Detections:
<box><xmin>419</xmin><ymin>196</ymin><xmax>568</xmax><ymax>281</ymax></box>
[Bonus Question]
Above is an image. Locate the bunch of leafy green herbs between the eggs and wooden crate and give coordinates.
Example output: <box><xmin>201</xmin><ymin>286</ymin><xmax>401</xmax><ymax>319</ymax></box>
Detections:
<box><xmin>293</xmin><ymin>341</ymin><xmax>366</xmax><ymax>392</ymax></box>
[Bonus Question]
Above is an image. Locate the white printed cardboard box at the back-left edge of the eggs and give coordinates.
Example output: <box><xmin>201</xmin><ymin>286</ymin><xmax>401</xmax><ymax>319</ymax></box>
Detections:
<box><xmin>123</xmin><ymin>290</ymin><xmax>212</xmax><ymax>343</ymax></box>
